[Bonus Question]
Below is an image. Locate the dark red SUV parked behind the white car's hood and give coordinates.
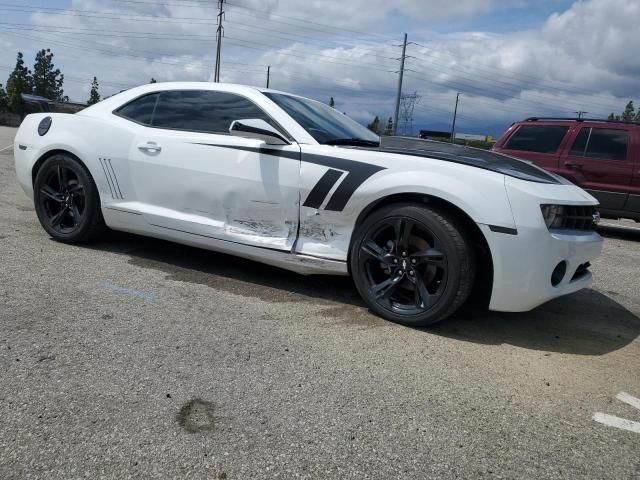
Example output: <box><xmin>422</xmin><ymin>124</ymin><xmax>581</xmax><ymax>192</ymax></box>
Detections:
<box><xmin>493</xmin><ymin>118</ymin><xmax>640</xmax><ymax>222</ymax></box>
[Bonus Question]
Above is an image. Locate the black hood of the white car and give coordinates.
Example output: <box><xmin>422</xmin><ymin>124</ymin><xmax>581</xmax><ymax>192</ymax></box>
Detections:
<box><xmin>370</xmin><ymin>137</ymin><xmax>567</xmax><ymax>184</ymax></box>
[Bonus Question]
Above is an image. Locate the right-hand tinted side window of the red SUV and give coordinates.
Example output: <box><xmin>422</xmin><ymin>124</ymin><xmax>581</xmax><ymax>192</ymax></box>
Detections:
<box><xmin>569</xmin><ymin>127</ymin><xmax>629</xmax><ymax>160</ymax></box>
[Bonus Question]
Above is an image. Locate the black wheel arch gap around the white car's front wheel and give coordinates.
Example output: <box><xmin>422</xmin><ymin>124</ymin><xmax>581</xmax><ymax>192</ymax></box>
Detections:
<box><xmin>347</xmin><ymin>192</ymin><xmax>493</xmax><ymax>307</ymax></box>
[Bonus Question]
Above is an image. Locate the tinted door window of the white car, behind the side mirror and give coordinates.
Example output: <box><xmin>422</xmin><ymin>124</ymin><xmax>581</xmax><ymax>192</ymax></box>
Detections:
<box><xmin>152</xmin><ymin>90</ymin><xmax>272</xmax><ymax>134</ymax></box>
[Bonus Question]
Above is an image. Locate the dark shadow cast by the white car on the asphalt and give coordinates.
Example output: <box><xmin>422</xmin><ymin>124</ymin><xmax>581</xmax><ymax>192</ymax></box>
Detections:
<box><xmin>85</xmin><ymin>232</ymin><xmax>640</xmax><ymax>355</ymax></box>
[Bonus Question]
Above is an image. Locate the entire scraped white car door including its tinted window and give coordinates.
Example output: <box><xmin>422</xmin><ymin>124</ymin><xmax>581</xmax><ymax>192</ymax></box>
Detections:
<box><xmin>129</xmin><ymin>91</ymin><xmax>300</xmax><ymax>251</ymax></box>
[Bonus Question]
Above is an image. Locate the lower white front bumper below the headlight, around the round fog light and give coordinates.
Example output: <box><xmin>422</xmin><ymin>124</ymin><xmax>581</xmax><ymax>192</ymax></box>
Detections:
<box><xmin>480</xmin><ymin>225</ymin><xmax>602</xmax><ymax>312</ymax></box>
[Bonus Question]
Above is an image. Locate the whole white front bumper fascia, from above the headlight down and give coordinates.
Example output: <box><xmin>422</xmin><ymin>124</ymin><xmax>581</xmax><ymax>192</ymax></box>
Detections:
<box><xmin>479</xmin><ymin>177</ymin><xmax>602</xmax><ymax>312</ymax></box>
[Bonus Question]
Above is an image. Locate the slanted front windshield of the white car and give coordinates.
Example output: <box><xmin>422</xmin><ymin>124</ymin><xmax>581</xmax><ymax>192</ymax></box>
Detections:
<box><xmin>264</xmin><ymin>92</ymin><xmax>380</xmax><ymax>145</ymax></box>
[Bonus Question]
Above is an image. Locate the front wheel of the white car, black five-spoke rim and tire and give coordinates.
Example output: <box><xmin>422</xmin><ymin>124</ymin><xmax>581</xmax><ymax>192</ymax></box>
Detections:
<box><xmin>349</xmin><ymin>204</ymin><xmax>475</xmax><ymax>327</ymax></box>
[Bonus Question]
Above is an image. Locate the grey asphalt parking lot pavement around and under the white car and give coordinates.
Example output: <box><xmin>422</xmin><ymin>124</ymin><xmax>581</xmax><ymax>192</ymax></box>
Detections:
<box><xmin>0</xmin><ymin>128</ymin><xmax>640</xmax><ymax>479</ymax></box>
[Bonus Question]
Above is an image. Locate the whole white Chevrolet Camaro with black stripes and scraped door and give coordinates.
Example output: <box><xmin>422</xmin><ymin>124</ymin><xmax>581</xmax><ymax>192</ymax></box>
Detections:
<box><xmin>14</xmin><ymin>83</ymin><xmax>602</xmax><ymax>325</ymax></box>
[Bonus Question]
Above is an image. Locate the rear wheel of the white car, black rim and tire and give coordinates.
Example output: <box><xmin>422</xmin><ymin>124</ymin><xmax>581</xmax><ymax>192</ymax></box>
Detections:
<box><xmin>33</xmin><ymin>154</ymin><xmax>106</xmax><ymax>243</ymax></box>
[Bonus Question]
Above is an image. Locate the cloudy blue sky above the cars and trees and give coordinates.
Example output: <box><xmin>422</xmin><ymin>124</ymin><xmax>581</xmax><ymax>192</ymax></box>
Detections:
<box><xmin>0</xmin><ymin>0</ymin><xmax>640</xmax><ymax>136</ymax></box>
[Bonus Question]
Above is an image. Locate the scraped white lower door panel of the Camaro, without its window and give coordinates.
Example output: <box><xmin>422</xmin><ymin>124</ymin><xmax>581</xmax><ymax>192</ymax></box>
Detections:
<box><xmin>131</xmin><ymin>129</ymin><xmax>300</xmax><ymax>251</ymax></box>
